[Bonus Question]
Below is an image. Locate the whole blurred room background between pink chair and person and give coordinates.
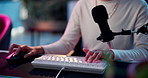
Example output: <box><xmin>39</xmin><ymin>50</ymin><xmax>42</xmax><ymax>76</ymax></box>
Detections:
<box><xmin>0</xmin><ymin>0</ymin><xmax>77</xmax><ymax>46</ymax></box>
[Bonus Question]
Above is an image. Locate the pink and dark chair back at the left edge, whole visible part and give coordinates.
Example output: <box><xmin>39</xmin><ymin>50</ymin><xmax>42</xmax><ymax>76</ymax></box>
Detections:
<box><xmin>0</xmin><ymin>14</ymin><xmax>12</xmax><ymax>50</ymax></box>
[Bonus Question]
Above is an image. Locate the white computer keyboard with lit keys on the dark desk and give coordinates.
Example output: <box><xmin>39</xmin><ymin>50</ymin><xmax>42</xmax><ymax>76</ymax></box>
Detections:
<box><xmin>31</xmin><ymin>54</ymin><xmax>107</xmax><ymax>74</ymax></box>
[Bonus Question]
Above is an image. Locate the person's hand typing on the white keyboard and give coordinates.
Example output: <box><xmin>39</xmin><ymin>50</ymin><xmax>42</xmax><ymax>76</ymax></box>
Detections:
<box><xmin>83</xmin><ymin>48</ymin><xmax>114</xmax><ymax>63</ymax></box>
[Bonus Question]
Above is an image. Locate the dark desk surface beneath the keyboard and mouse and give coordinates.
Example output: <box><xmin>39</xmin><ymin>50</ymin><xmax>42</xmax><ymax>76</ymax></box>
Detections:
<box><xmin>0</xmin><ymin>52</ymin><xmax>128</xmax><ymax>78</ymax></box>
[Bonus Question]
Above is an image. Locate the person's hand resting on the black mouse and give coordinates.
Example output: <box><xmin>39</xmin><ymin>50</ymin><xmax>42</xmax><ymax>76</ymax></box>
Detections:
<box><xmin>9</xmin><ymin>44</ymin><xmax>44</xmax><ymax>58</ymax></box>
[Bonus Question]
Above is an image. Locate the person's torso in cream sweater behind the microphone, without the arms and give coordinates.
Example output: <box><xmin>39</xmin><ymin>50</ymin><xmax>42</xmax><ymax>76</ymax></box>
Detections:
<box><xmin>77</xmin><ymin>0</ymin><xmax>142</xmax><ymax>50</ymax></box>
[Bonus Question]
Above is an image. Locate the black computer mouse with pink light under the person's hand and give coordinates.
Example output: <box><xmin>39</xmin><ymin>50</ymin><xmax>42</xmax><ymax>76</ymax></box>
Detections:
<box><xmin>6</xmin><ymin>51</ymin><xmax>41</xmax><ymax>63</ymax></box>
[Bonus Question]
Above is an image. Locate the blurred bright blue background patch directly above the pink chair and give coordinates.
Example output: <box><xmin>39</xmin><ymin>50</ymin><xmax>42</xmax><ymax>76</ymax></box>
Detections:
<box><xmin>0</xmin><ymin>0</ymin><xmax>22</xmax><ymax>28</ymax></box>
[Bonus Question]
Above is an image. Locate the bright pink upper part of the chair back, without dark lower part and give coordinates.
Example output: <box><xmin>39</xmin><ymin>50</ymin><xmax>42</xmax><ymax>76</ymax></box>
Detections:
<box><xmin>0</xmin><ymin>14</ymin><xmax>11</xmax><ymax>40</ymax></box>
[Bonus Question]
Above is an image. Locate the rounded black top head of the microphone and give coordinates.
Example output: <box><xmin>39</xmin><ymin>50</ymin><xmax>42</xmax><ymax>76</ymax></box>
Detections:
<box><xmin>92</xmin><ymin>5</ymin><xmax>108</xmax><ymax>23</ymax></box>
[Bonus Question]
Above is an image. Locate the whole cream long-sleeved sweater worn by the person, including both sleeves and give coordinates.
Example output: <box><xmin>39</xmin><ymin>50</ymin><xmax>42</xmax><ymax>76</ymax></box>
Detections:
<box><xmin>42</xmin><ymin>0</ymin><xmax>148</xmax><ymax>61</ymax></box>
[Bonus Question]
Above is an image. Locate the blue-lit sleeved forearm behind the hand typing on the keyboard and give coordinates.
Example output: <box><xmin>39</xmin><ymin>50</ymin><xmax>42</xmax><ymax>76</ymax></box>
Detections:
<box><xmin>112</xmin><ymin>48</ymin><xmax>148</xmax><ymax>61</ymax></box>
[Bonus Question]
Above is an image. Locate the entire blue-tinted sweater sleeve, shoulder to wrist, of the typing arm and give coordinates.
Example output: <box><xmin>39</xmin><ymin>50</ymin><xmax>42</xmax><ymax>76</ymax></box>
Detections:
<box><xmin>113</xmin><ymin>2</ymin><xmax>148</xmax><ymax>61</ymax></box>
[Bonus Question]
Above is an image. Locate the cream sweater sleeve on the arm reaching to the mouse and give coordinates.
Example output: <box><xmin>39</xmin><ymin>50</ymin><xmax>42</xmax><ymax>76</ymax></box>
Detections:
<box><xmin>42</xmin><ymin>1</ymin><xmax>81</xmax><ymax>54</ymax></box>
